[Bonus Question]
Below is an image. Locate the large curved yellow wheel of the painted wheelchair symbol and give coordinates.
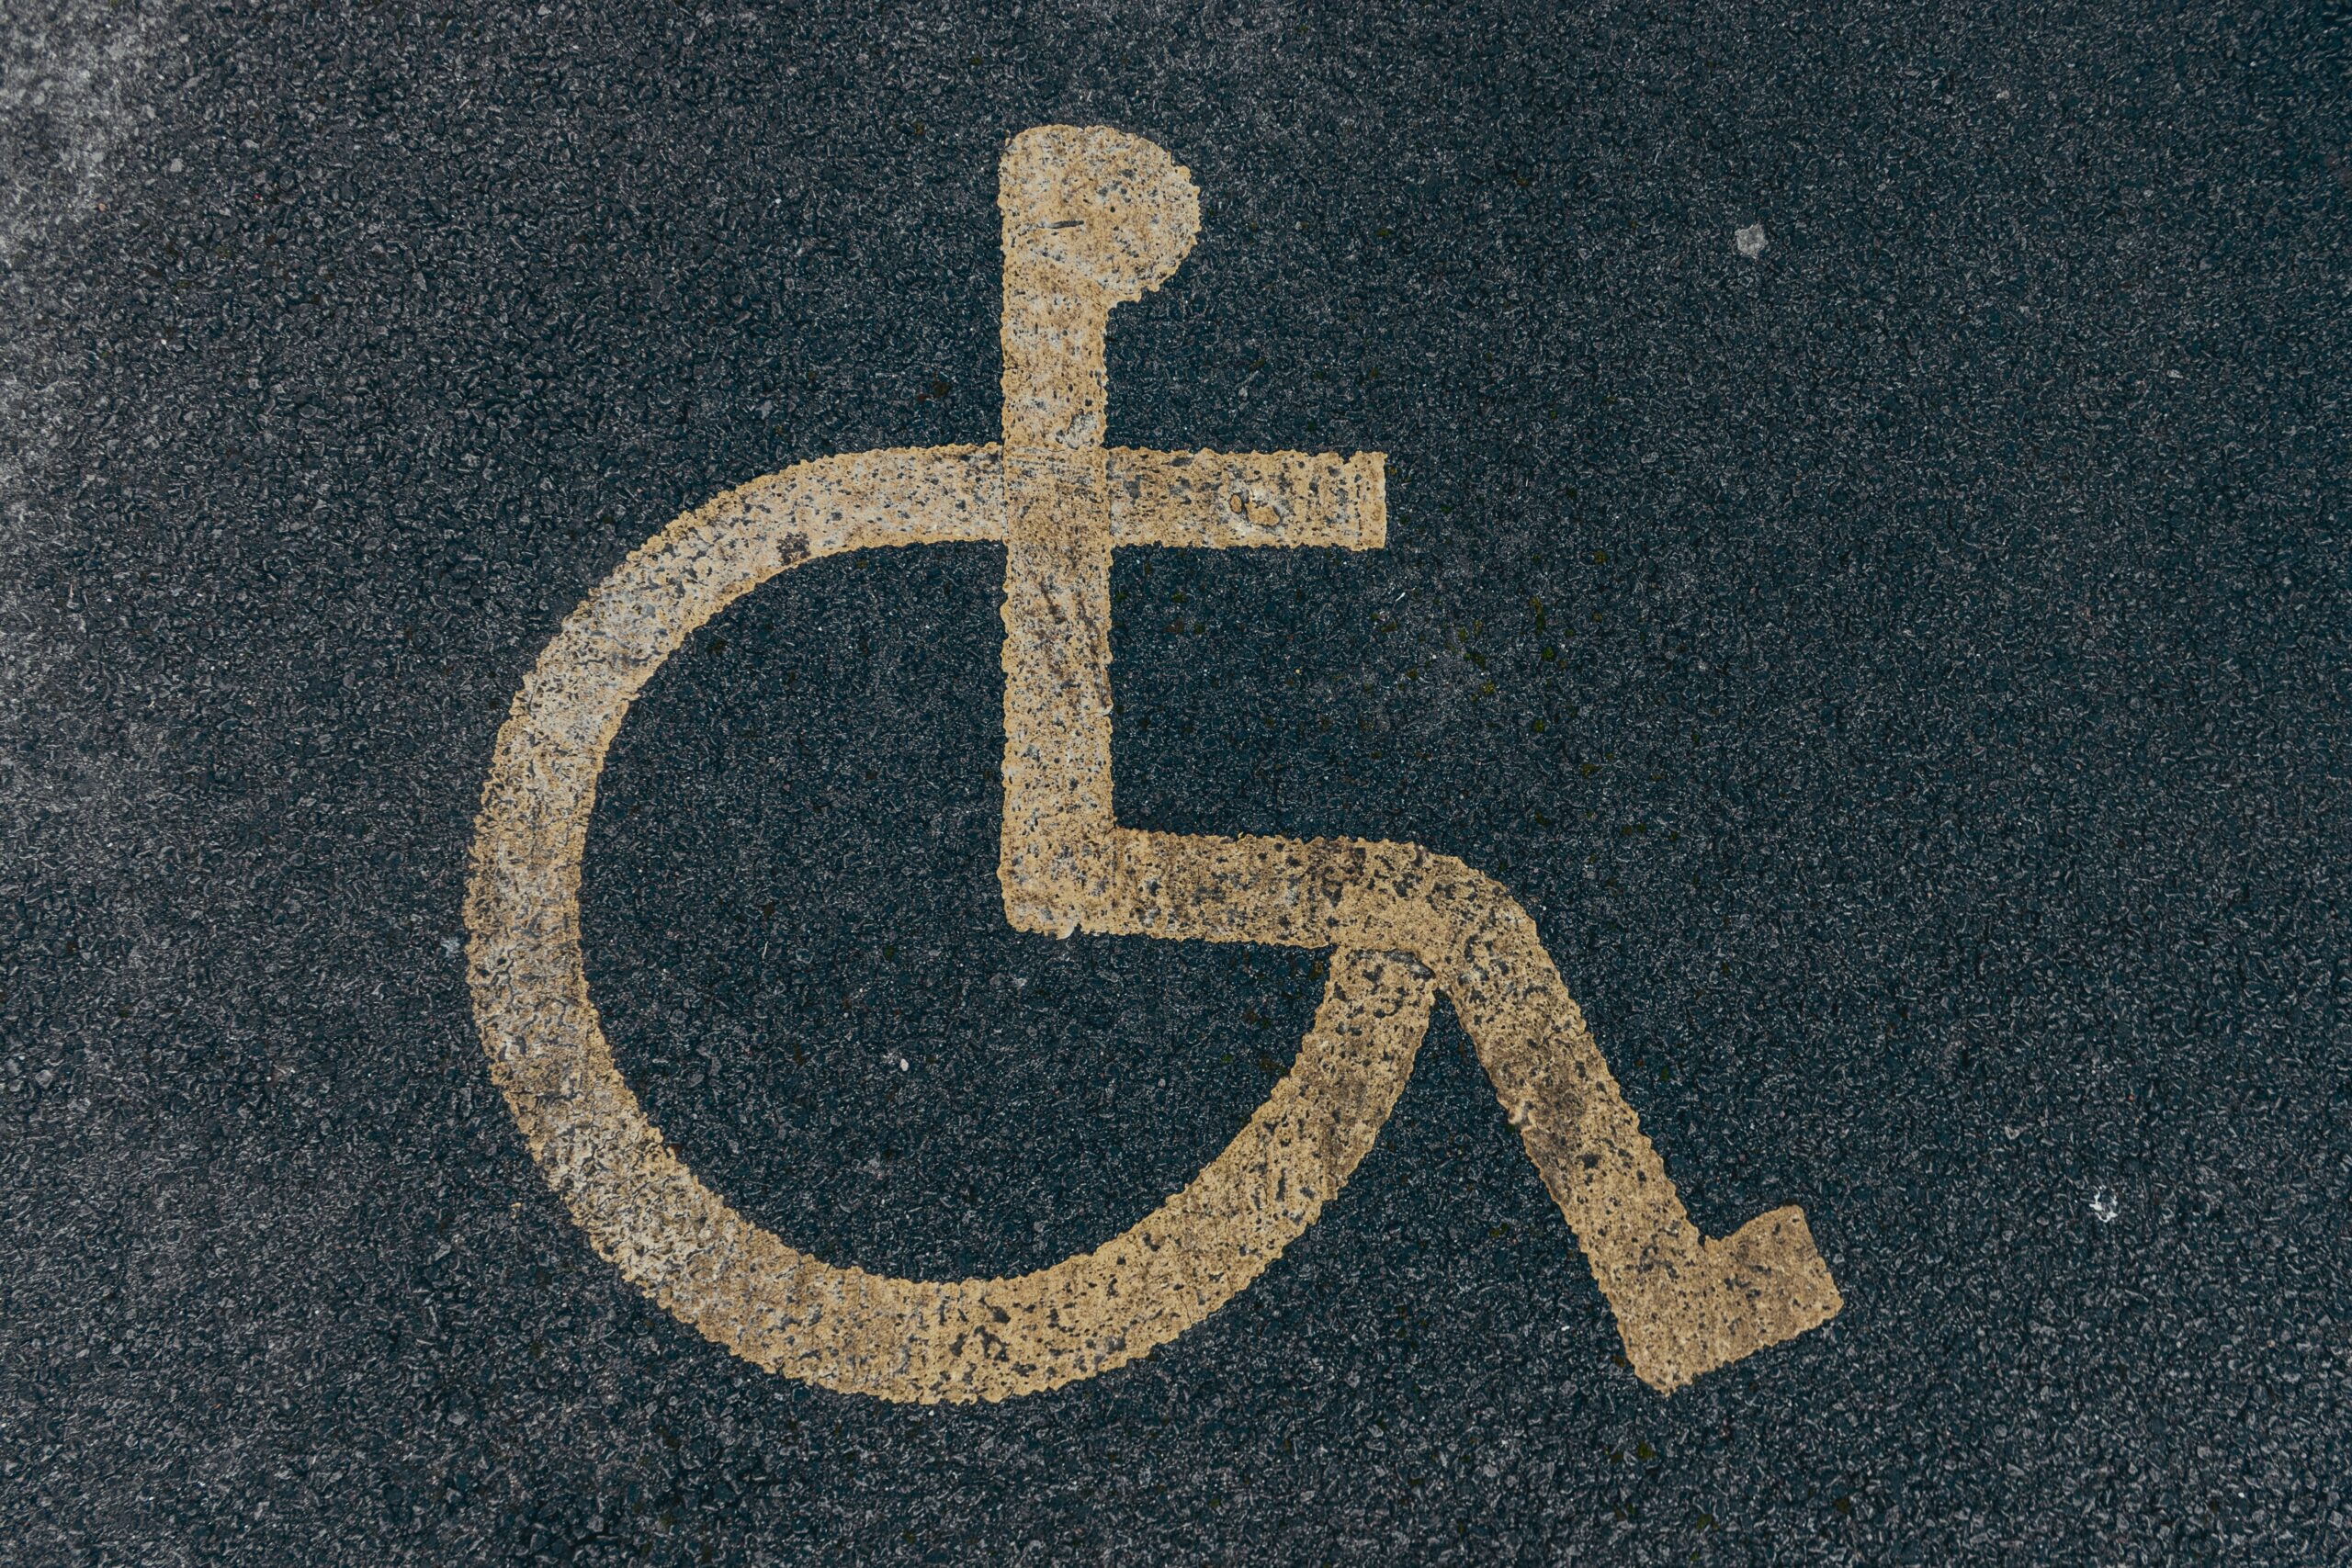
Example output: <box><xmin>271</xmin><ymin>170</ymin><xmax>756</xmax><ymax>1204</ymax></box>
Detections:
<box><xmin>466</xmin><ymin>446</ymin><xmax>1435</xmax><ymax>1404</ymax></box>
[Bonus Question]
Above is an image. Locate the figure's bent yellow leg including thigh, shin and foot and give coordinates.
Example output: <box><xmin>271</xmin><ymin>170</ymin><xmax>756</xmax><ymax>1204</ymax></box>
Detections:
<box><xmin>1101</xmin><ymin>832</ymin><xmax>1841</xmax><ymax>1392</ymax></box>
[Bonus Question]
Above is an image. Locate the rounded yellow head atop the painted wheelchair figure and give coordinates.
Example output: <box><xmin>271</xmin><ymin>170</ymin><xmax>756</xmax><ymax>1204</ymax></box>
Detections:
<box><xmin>997</xmin><ymin>125</ymin><xmax>1200</xmax><ymax>306</ymax></box>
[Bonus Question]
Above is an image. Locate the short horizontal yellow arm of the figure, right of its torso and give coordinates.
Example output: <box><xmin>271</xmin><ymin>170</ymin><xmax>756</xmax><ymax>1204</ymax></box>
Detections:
<box><xmin>1105</xmin><ymin>446</ymin><xmax>1387</xmax><ymax>550</ymax></box>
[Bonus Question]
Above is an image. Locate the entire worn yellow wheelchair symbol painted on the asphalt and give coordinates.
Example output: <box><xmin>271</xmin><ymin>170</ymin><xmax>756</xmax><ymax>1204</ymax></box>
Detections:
<box><xmin>466</xmin><ymin>125</ymin><xmax>1841</xmax><ymax>1401</ymax></box>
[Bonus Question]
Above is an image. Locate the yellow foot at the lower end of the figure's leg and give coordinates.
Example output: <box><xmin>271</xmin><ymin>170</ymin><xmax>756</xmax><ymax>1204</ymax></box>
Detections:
<box><xmin>1611</xmin><ymin>1206</ymin><xmax>1847</xmax><ymax>1394</ymax></box>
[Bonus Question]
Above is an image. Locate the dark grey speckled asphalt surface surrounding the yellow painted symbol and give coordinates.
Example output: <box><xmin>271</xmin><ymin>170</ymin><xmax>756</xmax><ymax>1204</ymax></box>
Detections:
<box><xmin>0</xmin><ymin>0</ymin><xmax>2352</xmax><ymax>1563</ymax></box>
